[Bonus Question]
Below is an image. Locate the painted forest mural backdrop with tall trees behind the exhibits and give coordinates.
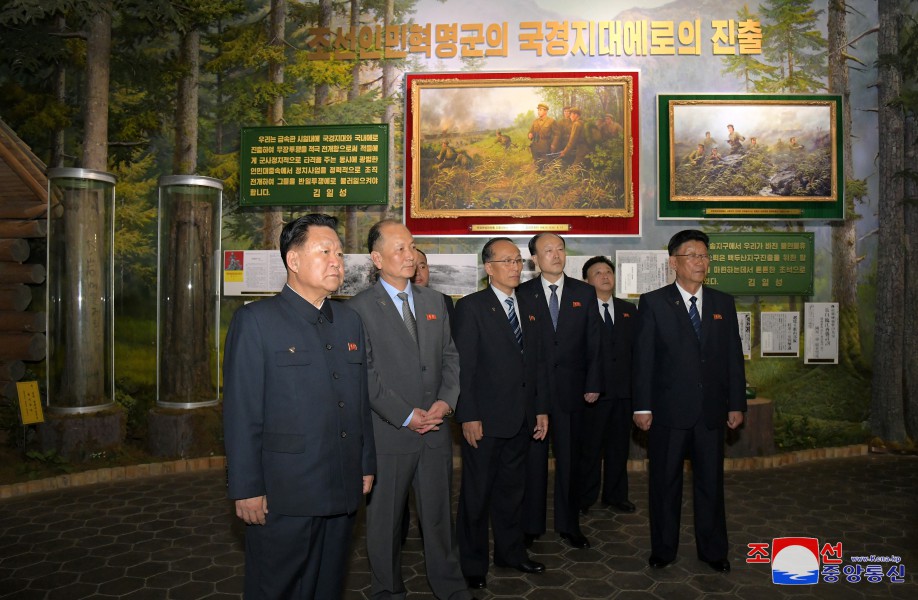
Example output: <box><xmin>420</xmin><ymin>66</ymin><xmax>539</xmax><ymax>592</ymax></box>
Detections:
<box><xmin>0</xmin><ymin>0</ymin><xmax>918</xmax><ymax>448</ymax></box>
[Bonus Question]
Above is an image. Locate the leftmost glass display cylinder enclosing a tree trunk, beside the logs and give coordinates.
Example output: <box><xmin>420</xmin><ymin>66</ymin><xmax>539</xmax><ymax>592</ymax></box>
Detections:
<box><xmin>46</xmin><ymin>168</ymin><xmax>115</xmax><ymax>413</ymax></box>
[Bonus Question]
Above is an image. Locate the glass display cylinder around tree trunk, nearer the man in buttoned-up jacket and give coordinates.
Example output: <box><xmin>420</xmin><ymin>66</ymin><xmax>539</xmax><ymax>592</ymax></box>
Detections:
<box><xmin>156</xmin><ymin>175</ymin><xmax>223</xmax><ymax>408</ymax></box>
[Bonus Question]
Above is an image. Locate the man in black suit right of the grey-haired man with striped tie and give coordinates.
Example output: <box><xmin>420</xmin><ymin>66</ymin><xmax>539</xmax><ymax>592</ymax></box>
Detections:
<box><xmin>518</xmin><ymin>233</ymin><xmax>602</xmax><ymax>548</ymax></box>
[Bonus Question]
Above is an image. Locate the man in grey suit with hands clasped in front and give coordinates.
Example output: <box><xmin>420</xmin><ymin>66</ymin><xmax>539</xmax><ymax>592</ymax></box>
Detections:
<box><xmin>348</xmin><ymin>220</ymin><xmax>471</xmax><ymax>600</ymax></box>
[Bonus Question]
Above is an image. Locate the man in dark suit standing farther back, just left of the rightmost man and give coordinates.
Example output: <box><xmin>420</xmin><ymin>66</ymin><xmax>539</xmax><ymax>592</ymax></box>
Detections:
<box><xmin>577</xmin><ymin>256</ymin><xmax>637</xmax><ymax>514</ymax></box>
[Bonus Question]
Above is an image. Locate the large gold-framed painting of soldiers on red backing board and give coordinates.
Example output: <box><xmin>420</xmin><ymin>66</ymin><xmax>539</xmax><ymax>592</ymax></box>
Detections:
<box><xmin>405</xmin><ymin>71</ymin><xmax>640</xmax><ymax>236</ymax></box>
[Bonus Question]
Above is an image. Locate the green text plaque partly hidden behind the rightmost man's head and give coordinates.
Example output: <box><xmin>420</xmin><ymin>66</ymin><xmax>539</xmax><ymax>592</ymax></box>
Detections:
<box><xmin>705</xmin><ymin>232</ymin><xmax>815</xmax><ymax>296</ymax></box>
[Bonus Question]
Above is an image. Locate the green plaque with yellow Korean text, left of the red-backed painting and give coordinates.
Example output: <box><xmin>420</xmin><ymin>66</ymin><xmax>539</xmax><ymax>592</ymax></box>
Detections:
<box><xmin>239</xmin><ymin>124</ymin><xmax>389</xmax><ymax>206</ymax></box>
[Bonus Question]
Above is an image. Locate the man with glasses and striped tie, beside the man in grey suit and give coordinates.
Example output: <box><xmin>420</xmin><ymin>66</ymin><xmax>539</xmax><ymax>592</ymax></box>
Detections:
<box><xmin>456</xmin><ymin>238</ymin><xmax>548</xmax><ymax>589</ymax></box>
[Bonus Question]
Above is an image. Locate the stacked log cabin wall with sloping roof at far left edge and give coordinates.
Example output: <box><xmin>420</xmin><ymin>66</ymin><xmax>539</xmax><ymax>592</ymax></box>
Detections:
<box><xmin>0</xmin><ymin>120</ymin><xmax>48</xmax><ymax>400</ymax></box>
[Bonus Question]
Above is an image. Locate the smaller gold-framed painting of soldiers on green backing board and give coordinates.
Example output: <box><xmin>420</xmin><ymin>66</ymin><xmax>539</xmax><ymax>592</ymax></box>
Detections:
<box><xmin>657</xmin><ymin>94</ymin><xmax>844</xmax><ymax>220</ymax></box>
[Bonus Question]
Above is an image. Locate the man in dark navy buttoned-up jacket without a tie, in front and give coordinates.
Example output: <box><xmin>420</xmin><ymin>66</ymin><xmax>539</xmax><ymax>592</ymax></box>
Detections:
<box><xmin>223</xmin><ymin>214</ymin><xmax>376</xmax><ymax>600</ymax></box>
